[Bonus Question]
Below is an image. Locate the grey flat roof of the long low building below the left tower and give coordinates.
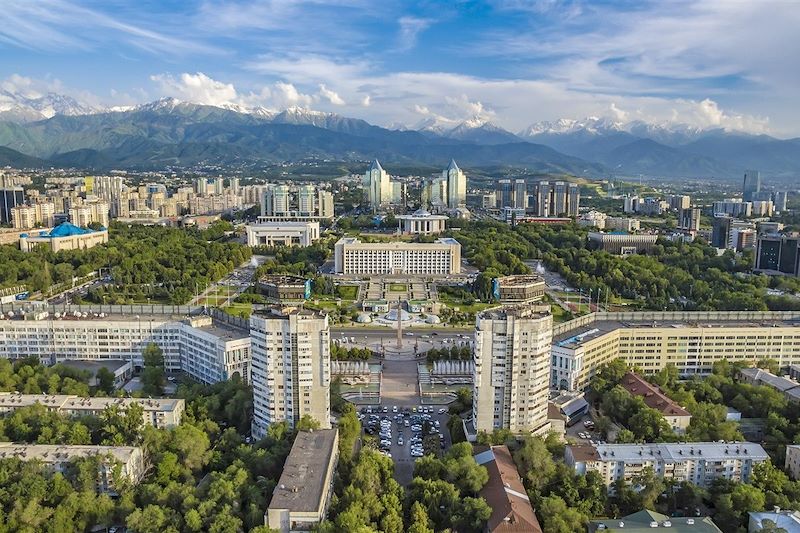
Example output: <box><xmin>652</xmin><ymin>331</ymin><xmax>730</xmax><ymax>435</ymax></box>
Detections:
<box><xmin>269</xmin><ymin>429</ymin><xmax>339</xmax><ymax>512</ymax></box>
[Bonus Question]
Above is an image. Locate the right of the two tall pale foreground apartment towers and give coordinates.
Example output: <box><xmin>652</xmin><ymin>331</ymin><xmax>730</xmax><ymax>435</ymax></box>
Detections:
<box><xmin>472</xmin><ymin>305</ymin><xmax>553</xmax><ymax>435</ymax></box>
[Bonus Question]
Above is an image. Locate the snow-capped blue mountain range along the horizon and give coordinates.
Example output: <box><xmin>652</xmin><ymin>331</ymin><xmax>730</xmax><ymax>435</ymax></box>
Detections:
<box><xmin>0</xmin><ymin>91</ymin><xmax>800</xmax><ymax>179</ymax></box>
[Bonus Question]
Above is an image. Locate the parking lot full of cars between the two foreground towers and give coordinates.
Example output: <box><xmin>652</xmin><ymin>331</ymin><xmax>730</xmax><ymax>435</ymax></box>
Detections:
<box><xmin>359</xmin><ymin>405</ymin><xmax>452</xmax><ymax>485</ymax></box>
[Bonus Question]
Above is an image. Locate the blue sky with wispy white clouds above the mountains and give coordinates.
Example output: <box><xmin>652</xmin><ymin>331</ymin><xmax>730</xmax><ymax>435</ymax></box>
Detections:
<box><xmin>0</xmin><ymin>0</ymin><xmax>800</xmax><ymax>137</ymax></box>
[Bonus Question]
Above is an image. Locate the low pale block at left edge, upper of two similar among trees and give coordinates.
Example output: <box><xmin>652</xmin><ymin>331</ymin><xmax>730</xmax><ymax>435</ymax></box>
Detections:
<box><xmin>0</xmin><ymin>392</ymin><xmax>186</xmax><ymax>429</ymax></box>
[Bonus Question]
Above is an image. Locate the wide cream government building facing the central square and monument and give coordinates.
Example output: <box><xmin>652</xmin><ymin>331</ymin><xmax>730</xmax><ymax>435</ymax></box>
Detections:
<box><xmin>334</xmin><ymin>237</ymin><xmax>461</xmax><ymax>276</ymax></box>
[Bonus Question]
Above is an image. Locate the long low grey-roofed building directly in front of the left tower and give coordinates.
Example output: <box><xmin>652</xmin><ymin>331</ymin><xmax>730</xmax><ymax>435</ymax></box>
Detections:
<box><xmin>264</xmin><ymin>429</ymin><xmax>339</xmax><ymax>533</ymax></box>
